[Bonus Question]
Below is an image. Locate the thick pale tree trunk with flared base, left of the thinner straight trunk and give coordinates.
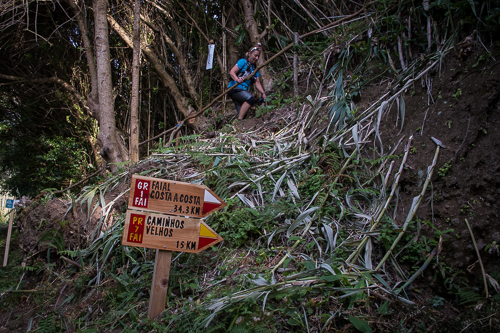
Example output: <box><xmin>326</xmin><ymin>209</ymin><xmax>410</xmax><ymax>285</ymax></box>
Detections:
<box><xmin>93</xmin><ymin>0</ymin><xmax>128</xmax><ymax>172</ymax></box>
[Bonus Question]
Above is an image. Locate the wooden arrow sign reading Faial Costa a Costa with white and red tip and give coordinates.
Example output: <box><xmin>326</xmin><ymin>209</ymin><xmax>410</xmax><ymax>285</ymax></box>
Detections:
<box><xmin>128</xmin><ymin>175</ymin><xmax>226</xmax><ymax>218</ymax></box>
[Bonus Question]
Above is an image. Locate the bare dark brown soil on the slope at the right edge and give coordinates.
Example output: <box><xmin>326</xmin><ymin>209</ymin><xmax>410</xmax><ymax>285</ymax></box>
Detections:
<box><xmin>382</xmin><ymin>49</ymin><xmax>500</xmax><ymax>280</ymax></box>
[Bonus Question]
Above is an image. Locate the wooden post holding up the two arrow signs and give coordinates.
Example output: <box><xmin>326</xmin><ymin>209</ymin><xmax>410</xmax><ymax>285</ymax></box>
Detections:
<box><xmin>148</xmin><ymin>249</ymin><xmax>172</xmax><ymax>319</ymax></box>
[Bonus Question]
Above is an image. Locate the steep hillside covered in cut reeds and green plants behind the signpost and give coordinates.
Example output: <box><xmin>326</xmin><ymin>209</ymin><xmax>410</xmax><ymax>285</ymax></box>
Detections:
<box><xmin>0</xmin><ymin>40</ymin><xmax>500</xmax><ymax>332</ymax></box>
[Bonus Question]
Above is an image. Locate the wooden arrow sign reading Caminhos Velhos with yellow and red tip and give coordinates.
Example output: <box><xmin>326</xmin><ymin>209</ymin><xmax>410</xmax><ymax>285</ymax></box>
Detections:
<box><xmin>122</xmin><ymin>210</ymin><xmax>223</xmax><ymax>253</ymax></box>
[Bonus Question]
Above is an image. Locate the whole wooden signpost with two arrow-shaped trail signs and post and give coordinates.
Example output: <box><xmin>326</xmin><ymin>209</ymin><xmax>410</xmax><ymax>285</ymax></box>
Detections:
<box><xmin>122</xmin><ymin>175</ymin><xmax>226</xmax><ymax>319</ymax></box>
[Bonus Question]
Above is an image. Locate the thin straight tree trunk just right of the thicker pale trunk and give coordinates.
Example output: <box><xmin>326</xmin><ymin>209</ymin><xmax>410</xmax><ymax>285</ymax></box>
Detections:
<box><xmin>129</xmin><ymin>0</ymin><xmax>141</xmax><ymax>162</ymax></box>
